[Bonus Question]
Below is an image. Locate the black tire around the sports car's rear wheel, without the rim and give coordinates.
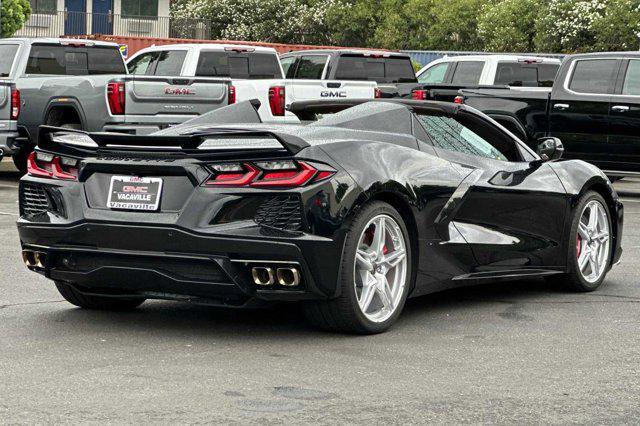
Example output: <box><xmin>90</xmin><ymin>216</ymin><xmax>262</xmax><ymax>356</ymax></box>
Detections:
<box><xmin>303</xmin><ymin>201</ymin><xmax>413</xmax><ymax>334</ymax></box>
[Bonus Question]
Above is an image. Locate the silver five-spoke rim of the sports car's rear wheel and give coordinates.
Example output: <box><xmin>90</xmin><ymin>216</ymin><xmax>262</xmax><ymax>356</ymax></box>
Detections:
<box><xmin>353</xmin><ymin>214</ymin><xmax>407</xmax><ymax>322</ymax></box>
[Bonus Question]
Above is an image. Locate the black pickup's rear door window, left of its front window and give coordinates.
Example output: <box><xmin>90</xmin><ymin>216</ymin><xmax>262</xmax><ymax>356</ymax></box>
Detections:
<box><xmin>569</xmin><ymin>59</ymin><xmax>618</xmax><ymax>95</ymax></box>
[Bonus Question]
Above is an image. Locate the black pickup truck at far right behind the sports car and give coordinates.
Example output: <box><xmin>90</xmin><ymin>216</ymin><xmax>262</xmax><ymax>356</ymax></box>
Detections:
<box><xmin>456</xmin><ymin>52</ymin><xmax>640</xmax><ymax>178</ymax></box>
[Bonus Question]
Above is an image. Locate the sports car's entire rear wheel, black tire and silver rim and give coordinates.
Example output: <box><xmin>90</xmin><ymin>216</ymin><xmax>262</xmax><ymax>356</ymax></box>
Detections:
<box><xmin>303</xmin><ymin>201</ymin><xmax>412</xmax><ymax>334</ymax></box>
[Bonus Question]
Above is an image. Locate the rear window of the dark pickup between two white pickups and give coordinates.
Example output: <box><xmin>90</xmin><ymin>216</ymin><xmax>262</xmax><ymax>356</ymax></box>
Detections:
<box><xmin>336</xmin><ymin>55</ymin><xmax>417</xmax><ymax>83</ymax></box>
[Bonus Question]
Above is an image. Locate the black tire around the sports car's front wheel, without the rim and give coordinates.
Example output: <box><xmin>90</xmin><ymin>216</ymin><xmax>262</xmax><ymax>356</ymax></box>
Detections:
<box><xmin>547</xmin><ymin>191</ymin><xmax>613</xmax><ymax>293</ymax></box>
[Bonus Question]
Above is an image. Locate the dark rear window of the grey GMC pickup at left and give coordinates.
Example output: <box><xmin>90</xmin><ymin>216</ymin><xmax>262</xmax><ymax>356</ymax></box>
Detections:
<box><xmin>26</xmin><ymin>44</ymin><xmax>126</xmax><ymax>75</ymax></box>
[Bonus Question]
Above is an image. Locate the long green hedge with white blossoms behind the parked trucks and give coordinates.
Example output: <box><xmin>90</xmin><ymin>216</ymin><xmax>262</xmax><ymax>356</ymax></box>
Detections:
<box><xmin>168</xmin><ymin>0</ymin><xmax>640</xmax><ymax>53</ymax></box>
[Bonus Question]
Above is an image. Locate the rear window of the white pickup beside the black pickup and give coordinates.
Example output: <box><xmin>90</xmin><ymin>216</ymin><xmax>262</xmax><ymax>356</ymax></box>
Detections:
<box><xmin>495</xmin><ymin>62</ymin><xmax>560</xmax><ymax>87</ymax></box>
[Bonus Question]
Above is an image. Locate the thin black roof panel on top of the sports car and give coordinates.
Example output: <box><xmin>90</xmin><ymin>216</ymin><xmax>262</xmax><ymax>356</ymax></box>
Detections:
<box><xmin>287</xmin><ymin>98</ymin><xmax>464</xmax><ymax>121</ymax></box>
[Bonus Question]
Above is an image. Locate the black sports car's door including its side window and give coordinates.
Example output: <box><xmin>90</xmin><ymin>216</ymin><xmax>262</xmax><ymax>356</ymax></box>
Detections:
<box><xmin>418</xmin><ymin>111</ymin><xmax>567</xmax><ymax>272</ymax></box>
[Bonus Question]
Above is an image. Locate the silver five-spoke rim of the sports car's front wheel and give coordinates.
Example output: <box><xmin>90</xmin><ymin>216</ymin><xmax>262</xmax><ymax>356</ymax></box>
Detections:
<box><xmin>576</xmin><ymin>200</ymin><xmax>611</xmax><ymax>283</ymax></box>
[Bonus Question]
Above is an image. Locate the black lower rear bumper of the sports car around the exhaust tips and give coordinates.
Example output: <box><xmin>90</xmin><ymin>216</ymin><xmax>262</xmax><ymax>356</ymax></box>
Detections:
<box><xmin>18</xmin><ymin>219</ymin><xmax>341</xmax><ymax>306</ymax></box>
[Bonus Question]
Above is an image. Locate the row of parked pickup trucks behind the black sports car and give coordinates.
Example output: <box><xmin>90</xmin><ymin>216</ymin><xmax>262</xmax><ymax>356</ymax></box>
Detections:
<box><xmin>0</xmin><ymin>39</ymin><xmax>640</xmax><ymax>178</ymax></box>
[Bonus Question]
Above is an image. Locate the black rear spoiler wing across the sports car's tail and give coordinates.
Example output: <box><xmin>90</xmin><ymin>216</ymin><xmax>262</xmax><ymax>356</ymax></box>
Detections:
<box><xmin>38</xmin><ymin>126</ymin><xmax>309</xmax><ymax>155</ymax></box>
